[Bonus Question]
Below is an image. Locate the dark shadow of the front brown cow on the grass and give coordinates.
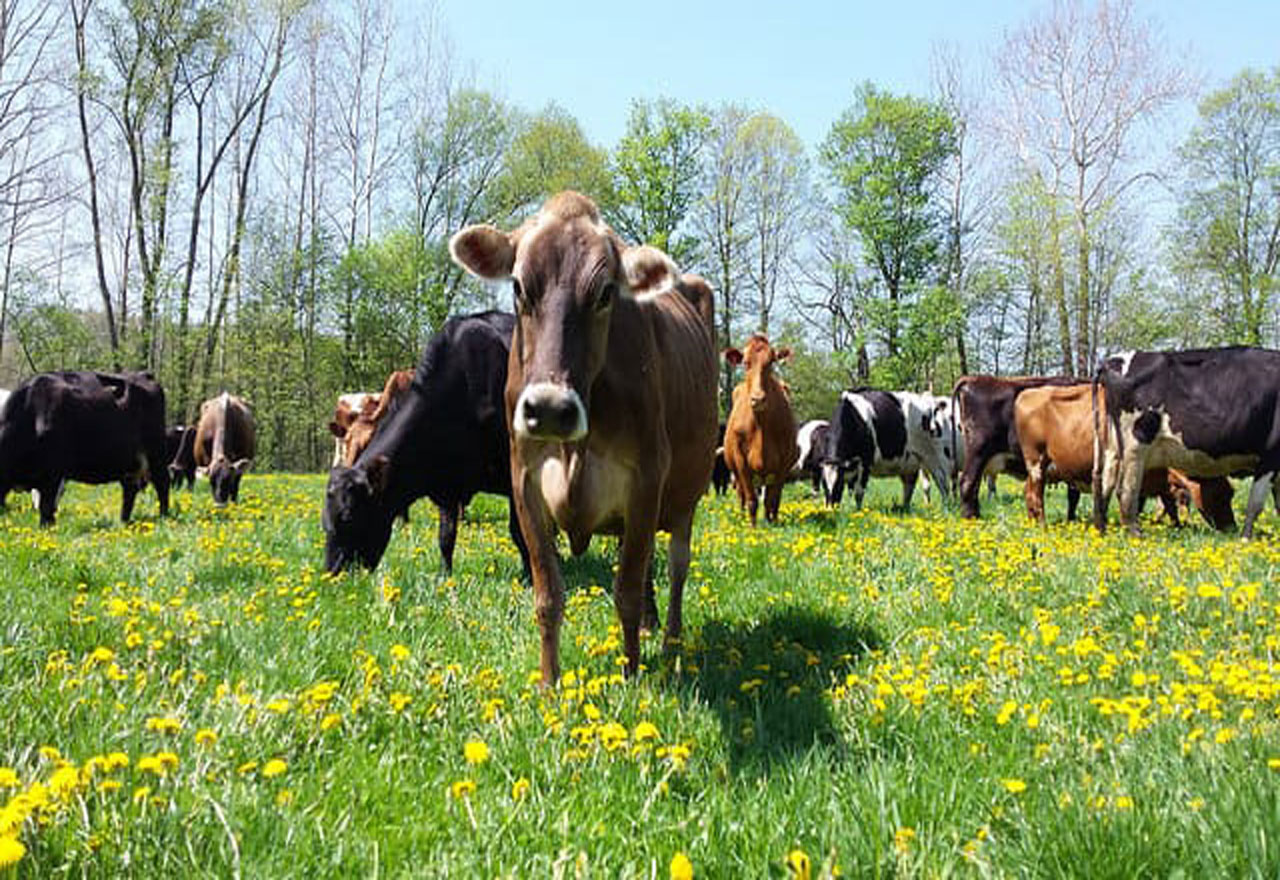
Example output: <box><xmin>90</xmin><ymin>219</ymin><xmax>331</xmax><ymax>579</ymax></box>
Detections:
<box><xmin>663</xmin><ymin>610</ymin><xmax>881</xmax><ymax>773</ymax></box>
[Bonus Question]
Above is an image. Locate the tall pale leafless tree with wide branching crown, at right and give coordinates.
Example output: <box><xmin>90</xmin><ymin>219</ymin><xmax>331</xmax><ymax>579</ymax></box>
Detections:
<box><xmin>996</xmin><ymin>0</ymin><xmax>1189</xmax><ymax>373</ymax></box>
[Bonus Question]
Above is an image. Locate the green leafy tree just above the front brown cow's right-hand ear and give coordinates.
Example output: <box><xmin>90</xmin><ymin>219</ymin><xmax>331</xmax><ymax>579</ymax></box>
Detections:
<box><xmin>603</xmin><ymin>98</ymin><xmax>710</xmax><ymax>265</ymax></box>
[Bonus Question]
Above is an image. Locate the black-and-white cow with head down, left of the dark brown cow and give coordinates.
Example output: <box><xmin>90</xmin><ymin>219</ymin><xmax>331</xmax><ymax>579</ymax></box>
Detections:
<box><xmin>822</xmin><ymin>390</ymin><xmax>951</xmax><ymax>509</ymax></box>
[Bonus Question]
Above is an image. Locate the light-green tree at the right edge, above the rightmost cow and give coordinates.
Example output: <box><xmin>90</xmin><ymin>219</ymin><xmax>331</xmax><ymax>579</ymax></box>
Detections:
<box><xmin>1175</xmin><ymin>68</ymin><xmax>1280</xmax><ymax>345</ymax></box>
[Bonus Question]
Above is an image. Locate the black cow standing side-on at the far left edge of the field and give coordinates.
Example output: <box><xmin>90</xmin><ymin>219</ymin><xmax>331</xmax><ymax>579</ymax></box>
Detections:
<box><xmin>0</xmin><ymin>371</ymin><xmax>169</xmax><ymax>526</ymax></box>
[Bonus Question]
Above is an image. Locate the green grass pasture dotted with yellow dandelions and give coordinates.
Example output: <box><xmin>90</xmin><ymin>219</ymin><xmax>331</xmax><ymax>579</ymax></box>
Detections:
<box><xmin>0</xmin><ymin>475</ymin><xmax>1280</xmax><ymax>879</ymax></box>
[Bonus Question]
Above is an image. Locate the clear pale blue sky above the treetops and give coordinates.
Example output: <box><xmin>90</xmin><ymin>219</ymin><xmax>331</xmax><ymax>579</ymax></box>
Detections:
<box><xmin>440</xmin><ymin>0</ymin><xmax>1280</xmax><ymax>147</ymax></box>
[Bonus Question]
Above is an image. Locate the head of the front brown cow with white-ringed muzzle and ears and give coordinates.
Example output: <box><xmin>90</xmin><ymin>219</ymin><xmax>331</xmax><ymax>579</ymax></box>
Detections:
<box><xmin>449</xmin><ymin>192</ymin><xmax>678</xmax><ymax>443</ymax></box>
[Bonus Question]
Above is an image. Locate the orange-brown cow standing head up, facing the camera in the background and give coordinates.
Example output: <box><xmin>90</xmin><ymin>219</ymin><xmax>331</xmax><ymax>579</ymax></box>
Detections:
<box><xmin>724</xmin><ymin>333</ymin><xmax>800</xmax><ymax>526</ymax></box>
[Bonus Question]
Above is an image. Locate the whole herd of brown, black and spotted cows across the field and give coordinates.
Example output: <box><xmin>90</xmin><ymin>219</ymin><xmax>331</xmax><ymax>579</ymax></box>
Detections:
<box><xmin>0</xmin><ymin>192</ymin><xmax>1280</xmax><ymax>683</ymax></box>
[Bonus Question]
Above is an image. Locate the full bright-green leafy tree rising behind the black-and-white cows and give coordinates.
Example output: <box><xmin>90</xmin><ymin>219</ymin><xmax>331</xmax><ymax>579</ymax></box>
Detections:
<box><xmin>822</xmin><ymin>83</ymin><xmax>955</xmax><ymax>378</ymax></box>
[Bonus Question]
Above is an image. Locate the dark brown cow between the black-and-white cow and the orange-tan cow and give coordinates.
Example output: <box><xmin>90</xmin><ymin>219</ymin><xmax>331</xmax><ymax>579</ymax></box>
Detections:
<box><xmin>951</xmin><ymin>376</ymin><xmax>1080</xmax><ymax>519</ymax></box>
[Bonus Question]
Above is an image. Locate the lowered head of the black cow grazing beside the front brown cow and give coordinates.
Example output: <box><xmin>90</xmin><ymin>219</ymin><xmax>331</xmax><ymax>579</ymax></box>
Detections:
<box><xmin>321</xmin><ymin>455</ymin><xmax>394</xmax><ymax>574</ymax></box>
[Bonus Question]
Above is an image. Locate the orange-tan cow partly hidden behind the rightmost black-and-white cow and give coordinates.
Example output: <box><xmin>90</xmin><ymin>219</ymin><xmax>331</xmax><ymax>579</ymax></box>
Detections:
<box><xmin>1014</xmin><ymin>384</ymin><xmax>1234</xmax><ymax>527</ymax></box>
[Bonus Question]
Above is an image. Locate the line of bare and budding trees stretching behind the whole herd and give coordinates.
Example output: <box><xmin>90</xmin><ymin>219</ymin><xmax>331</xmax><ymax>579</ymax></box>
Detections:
<box><xmin>0</xmin><ymin>0</ymin><xmax>1280</xmax><ymax>468</ymax></box>
